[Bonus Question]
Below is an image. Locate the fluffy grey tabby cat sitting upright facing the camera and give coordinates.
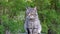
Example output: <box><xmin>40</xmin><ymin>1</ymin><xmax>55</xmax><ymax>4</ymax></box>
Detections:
<box><xmin>24</xmin><ymin>7</ymin><xmax>41</xmax><ymax>34</ymax></box>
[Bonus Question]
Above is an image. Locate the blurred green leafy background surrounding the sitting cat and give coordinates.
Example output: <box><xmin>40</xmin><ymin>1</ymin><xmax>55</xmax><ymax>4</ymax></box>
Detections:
<box><xmin>0</xmin><ymin>0</ymin><xmax>60</xmax><ymax>34</ymax></box>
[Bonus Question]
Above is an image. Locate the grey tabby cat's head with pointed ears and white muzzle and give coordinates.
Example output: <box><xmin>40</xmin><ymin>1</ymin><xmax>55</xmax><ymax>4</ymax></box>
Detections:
<box><xmin>26</xmin><ymin>7</ymin><xmax>37</xmax><ymax>19</ymax></box>
